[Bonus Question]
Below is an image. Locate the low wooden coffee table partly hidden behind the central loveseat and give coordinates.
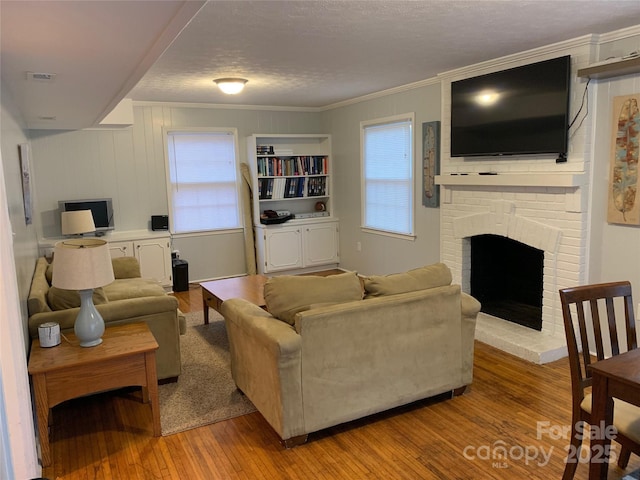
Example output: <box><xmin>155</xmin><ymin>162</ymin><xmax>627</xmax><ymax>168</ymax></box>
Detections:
<box><xmin>200</xmin><ymin>275</ymin><xmax>268</xmax><ymax>325</ymax></box>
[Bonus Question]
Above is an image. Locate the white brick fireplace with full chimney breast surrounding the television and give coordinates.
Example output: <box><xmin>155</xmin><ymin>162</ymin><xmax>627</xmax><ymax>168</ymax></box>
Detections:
<box><xmin>436</xmin><ymin>49</ymin><xmax>593</xmax><ymax>363</ymax></box>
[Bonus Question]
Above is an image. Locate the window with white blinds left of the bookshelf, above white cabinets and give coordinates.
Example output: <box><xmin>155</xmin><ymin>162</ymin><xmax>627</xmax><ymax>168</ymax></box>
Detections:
<box><xmin>167</xmin><ymin>129</ymin><xmax>242</xmax><ymax>233</ymax></box>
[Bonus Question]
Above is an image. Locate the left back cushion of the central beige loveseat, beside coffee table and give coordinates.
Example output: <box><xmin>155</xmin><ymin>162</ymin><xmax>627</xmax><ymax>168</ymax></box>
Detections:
<box><xmin>264</xmin><ymin>272</ymin><xmax>362</xmax><ymax>325</ymax></box>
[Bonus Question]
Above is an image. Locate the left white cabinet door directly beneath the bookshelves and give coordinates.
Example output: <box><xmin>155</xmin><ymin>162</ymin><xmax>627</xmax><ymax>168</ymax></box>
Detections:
<box><xmin>265</xmin><ymin>227</ymin><xmax>302</xmax><ymax>272</ymax></box>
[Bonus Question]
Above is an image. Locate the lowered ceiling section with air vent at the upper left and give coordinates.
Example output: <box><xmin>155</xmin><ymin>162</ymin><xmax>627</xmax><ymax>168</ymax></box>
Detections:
<box><xmin>0</xmin><ymin>0</ymin><xmax>204</xmax><ymax>129</ymax></box>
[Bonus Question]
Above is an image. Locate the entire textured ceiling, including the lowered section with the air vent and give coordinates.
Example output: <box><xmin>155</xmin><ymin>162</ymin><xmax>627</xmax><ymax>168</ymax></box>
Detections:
<box><xmin>0</xmin><ymin>0</ymin><xmax>640</xmax><ymax>129</ymax></box>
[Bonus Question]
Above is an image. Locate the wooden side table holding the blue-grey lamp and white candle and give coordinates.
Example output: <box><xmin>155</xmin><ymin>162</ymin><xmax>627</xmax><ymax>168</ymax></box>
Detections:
<box><xmin>29</xmin><ymin>323</ymin><xmax>160</xmax><ymax>467</ymax></box>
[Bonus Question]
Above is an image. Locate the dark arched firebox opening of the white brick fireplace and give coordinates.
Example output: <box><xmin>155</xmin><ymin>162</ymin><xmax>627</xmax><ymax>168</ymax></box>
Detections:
<box><xmin>470</xmin><ymin>235</ymin><xmax>544</xmax><ymax>331</ymax></box>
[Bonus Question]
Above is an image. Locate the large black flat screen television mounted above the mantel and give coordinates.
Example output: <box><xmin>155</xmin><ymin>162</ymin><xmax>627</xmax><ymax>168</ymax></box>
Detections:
<box><xmin>451</xmin><ymin>55</ymin><xmax>571</xmax><ymax>157</ymax></box>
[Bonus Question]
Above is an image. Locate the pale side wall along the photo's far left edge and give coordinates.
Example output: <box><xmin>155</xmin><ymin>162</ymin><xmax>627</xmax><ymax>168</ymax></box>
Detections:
<box><xmin>0</xmin><ymin>80</ymin><xmax>41</xmax><ymax>480</ymax></box>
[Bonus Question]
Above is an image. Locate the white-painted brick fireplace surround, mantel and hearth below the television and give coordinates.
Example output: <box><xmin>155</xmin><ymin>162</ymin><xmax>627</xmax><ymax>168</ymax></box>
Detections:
<box><xmin>438</xmin><ymin>172</ymin><xmax>587</xmax><ymax>363</ymax></box>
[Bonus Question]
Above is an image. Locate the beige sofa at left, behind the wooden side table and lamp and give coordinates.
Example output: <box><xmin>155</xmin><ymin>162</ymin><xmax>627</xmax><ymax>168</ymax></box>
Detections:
<box><xmin>27</xmin><ymin>257</ymin><xmax>186</xmax><ymax>380</ymax></box>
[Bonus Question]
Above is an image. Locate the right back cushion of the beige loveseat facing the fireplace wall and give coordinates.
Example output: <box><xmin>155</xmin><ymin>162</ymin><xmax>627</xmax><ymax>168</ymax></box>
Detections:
<box><xmin>363</xmin><ymin>263</ymin><xmax>452</xmax><ymax>298</ymax></box>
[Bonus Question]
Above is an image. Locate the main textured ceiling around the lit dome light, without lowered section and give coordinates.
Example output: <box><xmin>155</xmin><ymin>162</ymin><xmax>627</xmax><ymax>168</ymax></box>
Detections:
<box><xmin>129</xmin><ymin>0</ymin><xmax>640</xmax><ymax>107</ymax></box>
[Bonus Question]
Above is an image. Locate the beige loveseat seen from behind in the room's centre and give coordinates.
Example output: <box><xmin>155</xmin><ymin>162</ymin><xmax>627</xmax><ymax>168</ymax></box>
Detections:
<box><xmin>222</xmin><ymin>264</ymin><xmax>480</xmax><ymax>446</ymax></box>
